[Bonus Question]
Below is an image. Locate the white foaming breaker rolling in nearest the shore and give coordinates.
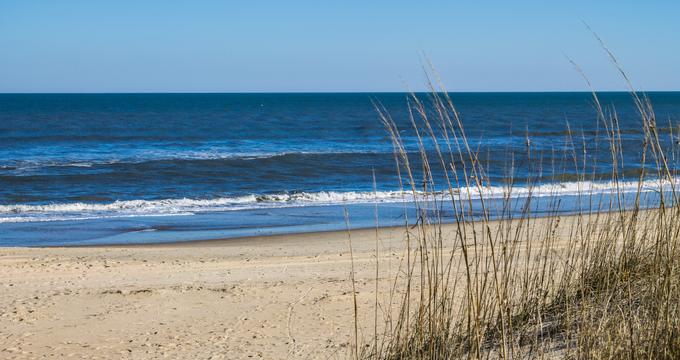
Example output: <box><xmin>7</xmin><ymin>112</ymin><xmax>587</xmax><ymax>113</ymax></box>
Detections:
<box><xmin>0</xmin><ymin>178</ymin><xmax>680</xmax><ymax>223</ymax></box>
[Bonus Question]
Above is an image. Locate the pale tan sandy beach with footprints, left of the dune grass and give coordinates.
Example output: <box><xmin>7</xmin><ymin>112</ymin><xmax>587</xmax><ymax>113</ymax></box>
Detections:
<box><xmin>0</xmin><ymin>228</ymin><xmax>436</xmax><ymax>359</ymax></box>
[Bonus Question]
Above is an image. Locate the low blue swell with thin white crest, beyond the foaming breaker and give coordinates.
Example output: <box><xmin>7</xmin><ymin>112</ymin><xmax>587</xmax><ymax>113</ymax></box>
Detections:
<box><xmin>0</xmin><ymin>136</ymin><xmax>604</xmax><ymax>176</ymax></box>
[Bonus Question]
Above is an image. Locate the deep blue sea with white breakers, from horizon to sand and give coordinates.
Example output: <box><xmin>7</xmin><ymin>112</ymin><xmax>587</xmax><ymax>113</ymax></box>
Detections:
<box><xmin>0</xmin><ymin>92</ymin><xmax>680</xmax><ymax>246</ymax></box>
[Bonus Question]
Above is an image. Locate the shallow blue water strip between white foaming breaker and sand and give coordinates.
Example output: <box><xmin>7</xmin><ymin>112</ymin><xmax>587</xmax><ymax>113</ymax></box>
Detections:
<box><xmin>0</xmin><ymin>192</ymin><xmax>672</xmax><ymax>247</ymax></box>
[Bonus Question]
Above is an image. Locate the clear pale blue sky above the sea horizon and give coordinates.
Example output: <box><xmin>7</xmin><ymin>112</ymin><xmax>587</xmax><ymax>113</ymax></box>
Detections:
<box><xmin>0</xmin><ymin>0</ymin><xmax>680</xmax><ymax>92</ymax></box>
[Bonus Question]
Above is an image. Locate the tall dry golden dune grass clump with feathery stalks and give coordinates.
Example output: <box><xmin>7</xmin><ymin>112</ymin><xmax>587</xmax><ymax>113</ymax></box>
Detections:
<box><xmin>353</xmin><ymin>58</ymin><xmax>680</xmax><ymax>359</ymax></box>
